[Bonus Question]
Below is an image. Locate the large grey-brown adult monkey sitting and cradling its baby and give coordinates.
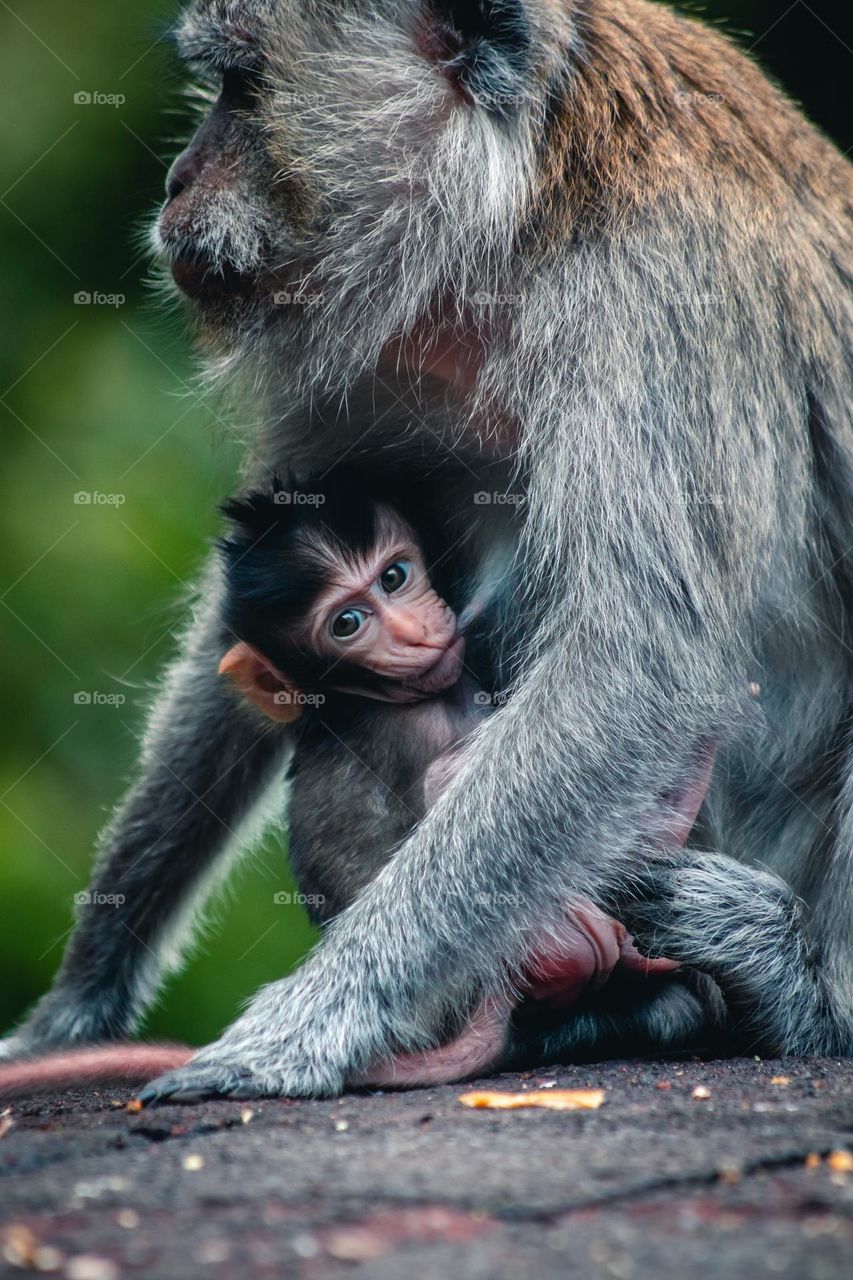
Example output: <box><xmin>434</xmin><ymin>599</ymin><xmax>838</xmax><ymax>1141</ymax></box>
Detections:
<box><xmin>1</xmin><ymin>0</ymin><xmax>853</xmax><ymax>1098</ymax></box>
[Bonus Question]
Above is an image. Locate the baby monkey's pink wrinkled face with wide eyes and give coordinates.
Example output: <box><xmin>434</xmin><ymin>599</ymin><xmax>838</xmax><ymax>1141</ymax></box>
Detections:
<box><xmin>298</xmin><ymin>508</ymin><xmax>465</xmax><ymax>701</ymax></box>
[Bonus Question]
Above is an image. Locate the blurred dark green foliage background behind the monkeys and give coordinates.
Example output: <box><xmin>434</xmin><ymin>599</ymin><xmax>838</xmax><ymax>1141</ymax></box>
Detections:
<box><xmin>0</xmin><ymin>0</ymin><xmax>853</xmax><ymax>1042</ymax></box>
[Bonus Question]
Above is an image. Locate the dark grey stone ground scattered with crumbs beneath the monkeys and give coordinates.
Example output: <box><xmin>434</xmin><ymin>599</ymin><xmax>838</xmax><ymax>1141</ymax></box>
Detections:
<box><xmin>0</xmin><ymin>1059</ymin><xmax>853</xmax><ymax>1280</ymax></box>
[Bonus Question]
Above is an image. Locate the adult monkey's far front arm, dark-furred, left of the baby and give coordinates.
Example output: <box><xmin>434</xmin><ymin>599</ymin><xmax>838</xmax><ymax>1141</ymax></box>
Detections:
<box><xmin>0</xmin><ymin>584</ymin><xmax>287</xmax><ymax>1057</ymax></box>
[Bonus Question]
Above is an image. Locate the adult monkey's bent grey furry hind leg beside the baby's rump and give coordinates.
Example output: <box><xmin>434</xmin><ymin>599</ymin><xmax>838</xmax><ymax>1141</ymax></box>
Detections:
<box><xmin>624</xmin><ymin>850</ymin><xmax>853</xmax><ymax>1056</ymax></box>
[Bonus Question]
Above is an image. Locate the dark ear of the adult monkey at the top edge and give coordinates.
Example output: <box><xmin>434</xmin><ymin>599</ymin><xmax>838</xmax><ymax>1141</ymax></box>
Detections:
<box><xmin>421</xmin><ymin>0</ymin><xmax>533</xmax><ymax>115</ymax></box>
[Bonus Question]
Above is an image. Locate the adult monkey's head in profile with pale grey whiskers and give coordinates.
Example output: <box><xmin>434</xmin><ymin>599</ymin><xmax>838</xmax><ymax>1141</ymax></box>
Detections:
<box><xmin>154</xmin><ymin>0</ymin><xmax>555</xmax><ymax>386</ymax></box>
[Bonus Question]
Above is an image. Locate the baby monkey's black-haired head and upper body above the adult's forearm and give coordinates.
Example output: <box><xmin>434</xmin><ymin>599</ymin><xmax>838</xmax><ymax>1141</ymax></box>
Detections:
<box><xmin>219</xmin><ymin>474</ymin><xmax>484</xmax><ymax>849</ymax></box>
